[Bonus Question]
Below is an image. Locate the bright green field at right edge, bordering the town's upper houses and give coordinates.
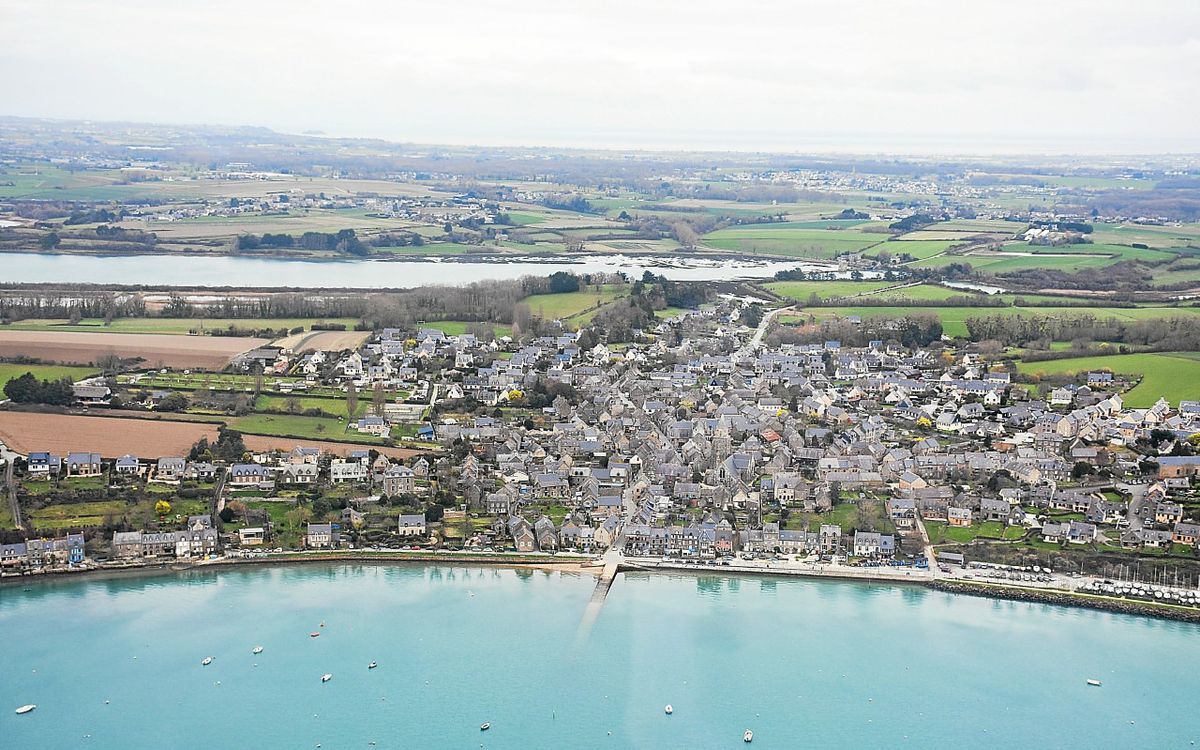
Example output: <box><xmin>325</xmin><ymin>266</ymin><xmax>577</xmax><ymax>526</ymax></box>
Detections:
<box><xmin>1018</xmin><ymin>352</ymin><xmax>1200</xmax><ymax>407</ymax></box>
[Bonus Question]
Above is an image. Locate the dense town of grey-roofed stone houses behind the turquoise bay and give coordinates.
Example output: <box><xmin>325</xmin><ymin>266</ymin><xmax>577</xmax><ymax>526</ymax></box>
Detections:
<box><xmin>0</xmin><ymin>283</ymin><xmax>1200</xmax><ymax>612</ymax></box>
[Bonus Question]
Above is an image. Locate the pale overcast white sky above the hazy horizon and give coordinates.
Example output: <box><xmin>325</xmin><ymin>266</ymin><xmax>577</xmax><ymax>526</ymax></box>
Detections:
<box><xmin>0</xmin><ymin>0</ymin><xmax>1200</xmax><ymax>154</ymax></box>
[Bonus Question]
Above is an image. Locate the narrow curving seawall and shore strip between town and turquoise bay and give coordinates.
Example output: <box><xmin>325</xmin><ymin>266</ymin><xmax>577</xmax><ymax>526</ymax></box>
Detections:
<box><xmin>9</xmin><ymin>551</ymin><xmax>1200</xmax><ymax>624</ymax></box>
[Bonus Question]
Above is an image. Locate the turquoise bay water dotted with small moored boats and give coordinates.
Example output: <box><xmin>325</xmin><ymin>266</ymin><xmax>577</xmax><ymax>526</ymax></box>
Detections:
<box><xmin>0</xmin><ymin>565</ymin><xmax>1200</xmax><ymax>750</ymax></box>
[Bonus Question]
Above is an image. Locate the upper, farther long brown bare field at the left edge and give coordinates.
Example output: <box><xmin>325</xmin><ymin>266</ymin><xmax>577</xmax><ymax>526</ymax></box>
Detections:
<box><xmin>0</xmin><ymin>329</ymin><xmax>269</xmax><ymax>370</ymax></box>
